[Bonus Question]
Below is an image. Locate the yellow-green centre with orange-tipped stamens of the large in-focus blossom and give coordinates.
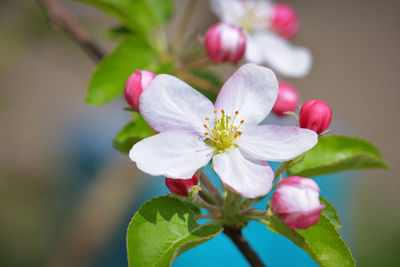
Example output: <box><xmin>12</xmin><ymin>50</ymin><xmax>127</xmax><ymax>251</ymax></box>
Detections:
<box><xmin>204</xmin><ymin>109</ymin><xmax>244</xmax><ymax>154</ymax></box>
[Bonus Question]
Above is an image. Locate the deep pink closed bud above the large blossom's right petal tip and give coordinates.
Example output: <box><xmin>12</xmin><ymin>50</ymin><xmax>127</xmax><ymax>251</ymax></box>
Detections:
<box><xmin>299</xmin><ymin>99</ymin><xmax>332</xmax><ymax>134</ymax></box>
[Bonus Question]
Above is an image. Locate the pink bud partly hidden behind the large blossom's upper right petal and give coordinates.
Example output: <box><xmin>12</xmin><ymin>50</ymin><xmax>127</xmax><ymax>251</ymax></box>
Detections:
<box><xmin>272</xmin><ymin>82</ymin><xmax>299</xmax><ymax>116</ymax></box>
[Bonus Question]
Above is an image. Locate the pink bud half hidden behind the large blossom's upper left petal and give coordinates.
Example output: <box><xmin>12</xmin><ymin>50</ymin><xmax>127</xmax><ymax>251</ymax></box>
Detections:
<box><xmin>124</xmin><ymin>70</ymin><xmax>156</xmax><ymax>112</ymax></box>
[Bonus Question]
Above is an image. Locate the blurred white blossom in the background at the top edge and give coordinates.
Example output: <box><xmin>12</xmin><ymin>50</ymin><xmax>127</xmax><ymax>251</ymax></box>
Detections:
<box><xmin>210</xmin><ymin>0</ymin><xmax>312</xmax><ymax>78</ymax></box>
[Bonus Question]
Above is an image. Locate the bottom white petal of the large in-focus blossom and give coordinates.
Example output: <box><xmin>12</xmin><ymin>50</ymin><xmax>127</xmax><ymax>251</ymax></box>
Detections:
<box><xmin>213</xmin><ymin>149</ymin><xmax>274</xmax><ymax>198</ymax></box>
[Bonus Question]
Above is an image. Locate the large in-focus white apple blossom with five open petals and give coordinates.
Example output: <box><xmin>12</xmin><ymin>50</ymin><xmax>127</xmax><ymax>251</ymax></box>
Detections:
<box><xmin>129</xmin><ymin>64</ymin><xmax>318</xmax><ymax>198</ymax></box>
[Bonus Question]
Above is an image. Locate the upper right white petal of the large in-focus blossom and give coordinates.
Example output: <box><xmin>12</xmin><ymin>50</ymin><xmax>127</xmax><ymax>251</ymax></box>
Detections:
<box><xmin>215</xmin><ymin>64</ymin><xmax>278</xmax><ymax>124</ymax></box>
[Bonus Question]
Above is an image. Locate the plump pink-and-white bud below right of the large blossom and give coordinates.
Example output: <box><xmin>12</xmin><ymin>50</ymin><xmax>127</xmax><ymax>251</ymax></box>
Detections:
<box><xmin>271</xmin><ymin>176</ymin><xmax>325</xmax><ymax>229</ymax></box>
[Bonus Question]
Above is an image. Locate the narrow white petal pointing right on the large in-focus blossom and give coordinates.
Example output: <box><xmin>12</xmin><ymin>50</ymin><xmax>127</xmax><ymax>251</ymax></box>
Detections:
<box><xmin>237</xmin><ymin>125</ymin><xmax>318</xmax><ymax>161</ymax></box>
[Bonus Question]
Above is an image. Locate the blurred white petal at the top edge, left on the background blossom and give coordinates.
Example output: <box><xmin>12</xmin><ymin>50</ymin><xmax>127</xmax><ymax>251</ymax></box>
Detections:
<box><xmin>210</xmin><ymin>0</ymin><xmax>246</xmax><ymax>25</ymax></box>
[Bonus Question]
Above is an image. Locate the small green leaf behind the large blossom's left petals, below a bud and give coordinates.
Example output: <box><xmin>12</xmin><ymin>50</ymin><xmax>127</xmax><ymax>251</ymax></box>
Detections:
<box><xmin>113</xmin><ymin>112</ymin><xmax>154</xmax><ymax>154</ymax></box>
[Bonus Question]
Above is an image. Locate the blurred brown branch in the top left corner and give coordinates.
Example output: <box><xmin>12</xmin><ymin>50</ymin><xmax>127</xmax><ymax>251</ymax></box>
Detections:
<box><xmin>37</xmin><ymin>0</ymin><xmax>104</xmax><ymax>63</ymax></box>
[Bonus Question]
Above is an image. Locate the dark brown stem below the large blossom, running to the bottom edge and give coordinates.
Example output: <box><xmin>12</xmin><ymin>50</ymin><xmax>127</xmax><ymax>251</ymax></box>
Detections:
<box><xmin>224</xmin><ymin>227</ymin><xmax>266</xmax><ymax>267</ymax></box>
